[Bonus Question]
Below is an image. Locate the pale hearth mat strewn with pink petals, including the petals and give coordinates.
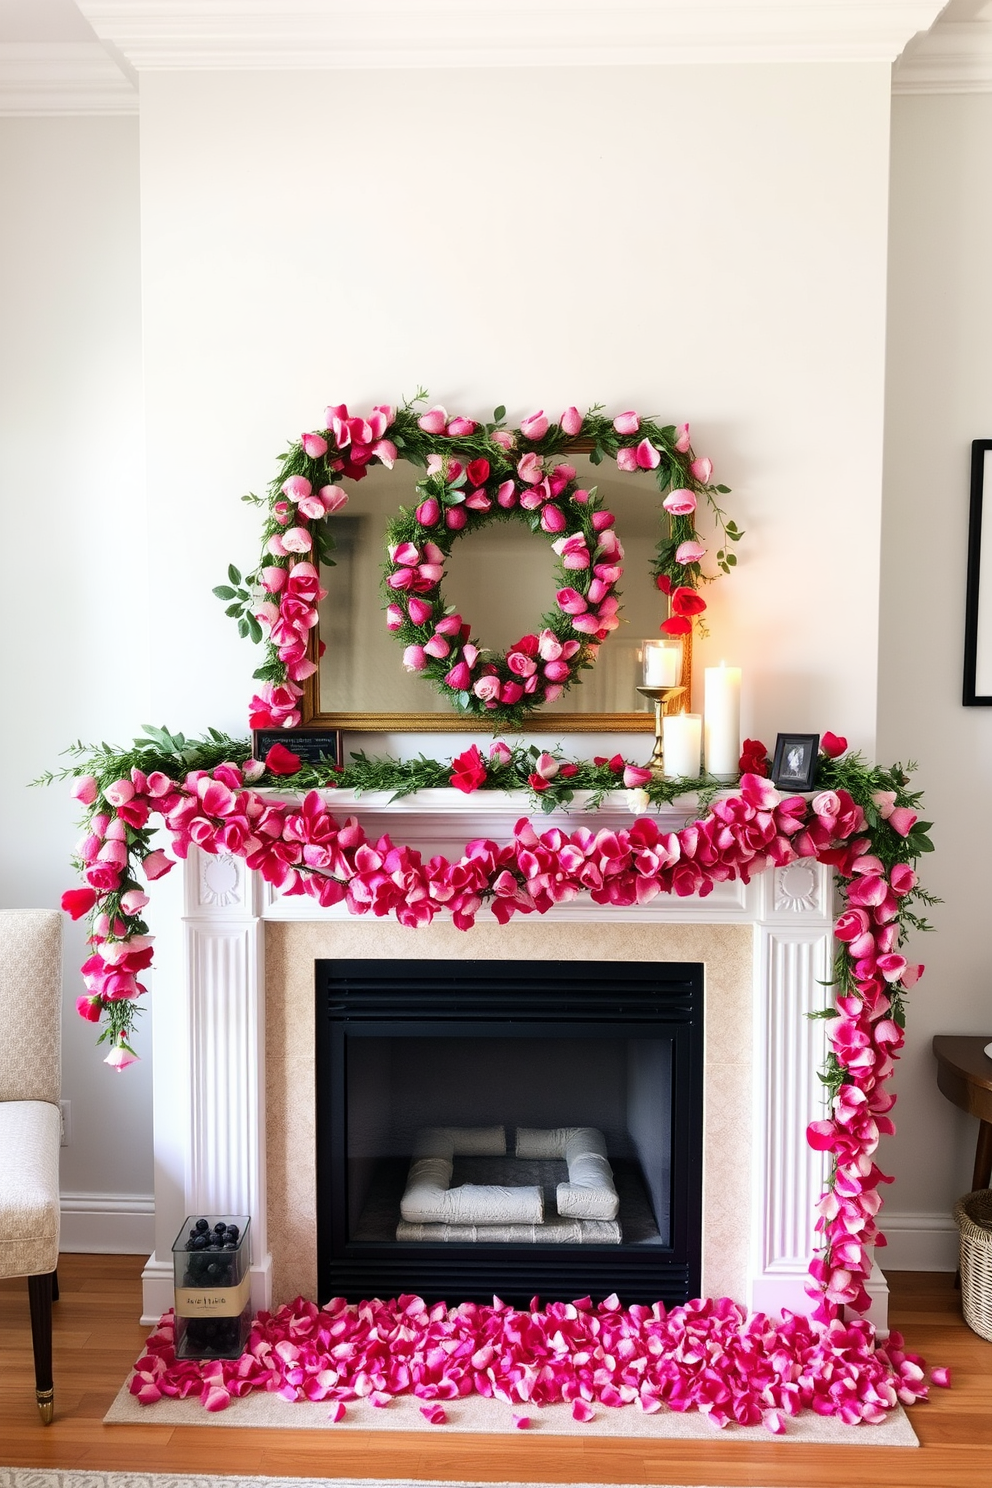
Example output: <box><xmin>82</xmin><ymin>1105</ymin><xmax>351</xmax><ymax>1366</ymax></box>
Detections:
<box><xmin>104</xmin><ymin>1296</ymin><xmax>922</xmax><ymax>1446</ymax></box>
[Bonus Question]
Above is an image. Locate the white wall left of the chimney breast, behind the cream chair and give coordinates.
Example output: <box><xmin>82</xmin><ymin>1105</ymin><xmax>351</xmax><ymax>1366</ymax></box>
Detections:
<box><xmin>0</xmin><ymin>119</ymin><xmax>152</xmax><ymax>1250</ymax></box>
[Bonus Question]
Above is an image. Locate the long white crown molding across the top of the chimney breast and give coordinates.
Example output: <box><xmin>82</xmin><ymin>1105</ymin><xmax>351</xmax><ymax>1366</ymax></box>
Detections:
<box><xmin>77</xmin><ymin>0</ymin><xmax>944</xmax><ymax>71</ymax></box>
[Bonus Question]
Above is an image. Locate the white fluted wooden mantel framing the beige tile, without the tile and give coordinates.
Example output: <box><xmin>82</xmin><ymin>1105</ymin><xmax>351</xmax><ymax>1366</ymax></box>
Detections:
<box><xmin>143</xmin><ymin>790</ymin><xmax>886</xmax><ymax>1326</ymax></box>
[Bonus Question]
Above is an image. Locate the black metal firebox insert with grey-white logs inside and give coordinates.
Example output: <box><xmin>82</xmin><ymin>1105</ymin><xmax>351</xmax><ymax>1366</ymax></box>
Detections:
<box><xmin>315</xmin><ymin>960</ymin><xmax>703</xmax><ymax>1305</ymax></box>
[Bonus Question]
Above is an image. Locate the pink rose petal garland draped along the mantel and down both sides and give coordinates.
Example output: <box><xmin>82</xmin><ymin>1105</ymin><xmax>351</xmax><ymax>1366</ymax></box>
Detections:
<box><xmin>64</xmin><ymin>747</ymin><xmax>928</xmax><ymax>1321</ymax></box>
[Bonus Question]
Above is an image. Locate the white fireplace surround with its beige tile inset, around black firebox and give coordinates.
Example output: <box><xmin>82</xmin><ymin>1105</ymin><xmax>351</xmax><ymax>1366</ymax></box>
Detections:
<box><xmin>143</xmin><ymin>809</ymin><xmax>885</xmax><ymax>1324</ymax></box>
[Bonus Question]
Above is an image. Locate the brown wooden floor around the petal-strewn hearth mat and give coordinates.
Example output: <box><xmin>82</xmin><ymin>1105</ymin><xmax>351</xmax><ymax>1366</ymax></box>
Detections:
<box><xmin>0</xmin><ymin>1256</ymin><xmax>992</xmax><ymax>1488</ymax></box>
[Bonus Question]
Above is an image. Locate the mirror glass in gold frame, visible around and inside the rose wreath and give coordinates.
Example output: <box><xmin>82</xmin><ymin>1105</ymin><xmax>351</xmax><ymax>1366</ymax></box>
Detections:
<box><xmin>318</xmin><ymin>454</ymin><xmax>668</xmax><ymax>717</ymax></box>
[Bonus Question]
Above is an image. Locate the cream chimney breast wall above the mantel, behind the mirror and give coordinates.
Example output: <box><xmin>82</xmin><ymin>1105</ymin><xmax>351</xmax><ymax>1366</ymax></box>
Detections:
<box><xmin>141</xmin><ymin>64</ymin><xmax>889</xmax><ymax>750</ymax></box>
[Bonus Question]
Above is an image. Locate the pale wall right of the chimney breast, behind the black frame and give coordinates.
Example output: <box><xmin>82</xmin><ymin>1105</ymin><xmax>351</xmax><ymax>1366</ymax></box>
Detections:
<box><xmin>879</xmin><ymin>94</ymin><xmax>992</xmax><ymax>1266</ymax></box>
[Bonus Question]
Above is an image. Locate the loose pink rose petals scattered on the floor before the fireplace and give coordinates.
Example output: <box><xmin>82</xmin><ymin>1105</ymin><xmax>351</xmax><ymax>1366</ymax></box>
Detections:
<box><xmin>129</xmin><ymin>1296</ymin><xmax>943</xmax><ymax>1436</ymax></box>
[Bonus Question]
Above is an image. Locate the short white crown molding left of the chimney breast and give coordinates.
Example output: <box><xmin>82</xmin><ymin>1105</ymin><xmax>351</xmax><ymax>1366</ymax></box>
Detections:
<box><xmin>0</xmin><ymin>42</ymin><xmax>138</xmax><ymax>118</ymax></box>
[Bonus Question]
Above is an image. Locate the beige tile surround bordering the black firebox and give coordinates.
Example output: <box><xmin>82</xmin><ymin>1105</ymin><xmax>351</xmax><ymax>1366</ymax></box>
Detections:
<box><xmin>265</xmin><ymin>920</ymin><xmax>756</xmax><ymax>1305</ymax></box>
